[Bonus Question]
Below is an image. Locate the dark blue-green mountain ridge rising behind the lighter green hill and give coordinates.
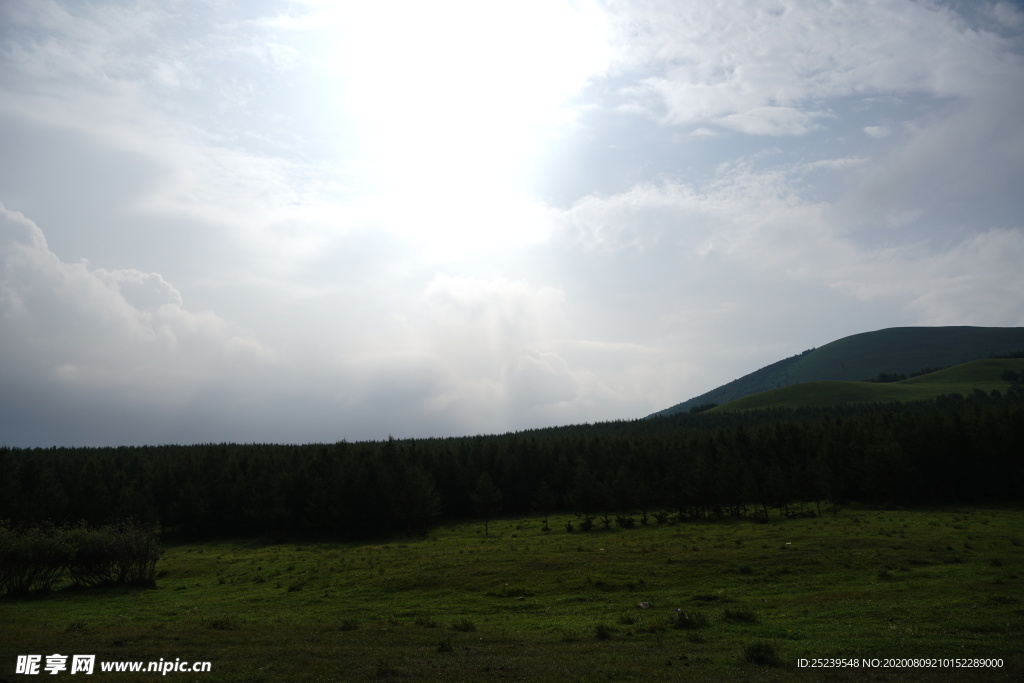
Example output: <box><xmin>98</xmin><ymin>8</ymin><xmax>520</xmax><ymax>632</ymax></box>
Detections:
<box><xmin>648</xmin><ymin>326</ymin><xmax>1024</xmax><ymax>417</ymax></box>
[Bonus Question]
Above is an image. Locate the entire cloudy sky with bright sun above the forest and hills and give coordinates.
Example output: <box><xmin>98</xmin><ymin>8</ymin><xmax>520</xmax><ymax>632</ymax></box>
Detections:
<box><xmin>0</xmin><ymin>0</ymin><xmax>1024</xmax><ymax>447</ymax></box>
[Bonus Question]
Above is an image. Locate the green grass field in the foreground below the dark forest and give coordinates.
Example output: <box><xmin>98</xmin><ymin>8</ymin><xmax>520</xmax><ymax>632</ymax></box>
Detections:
<box><xmin>0</xmin><ymin>508</ymin><xmax>1024</xmax><ymax>681</ymax></box>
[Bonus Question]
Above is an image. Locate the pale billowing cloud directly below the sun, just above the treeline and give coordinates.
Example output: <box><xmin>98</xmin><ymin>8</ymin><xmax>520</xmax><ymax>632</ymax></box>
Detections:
<box><xmin>360</xmin><ymin>274</ymin><xmax>645</xmax><ymax>433</ymax></box>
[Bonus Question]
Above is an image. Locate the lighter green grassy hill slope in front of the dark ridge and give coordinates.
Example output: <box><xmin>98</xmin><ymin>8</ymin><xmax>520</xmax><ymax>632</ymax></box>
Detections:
<box><xmin>714</xmin><ymin>358</ymin><xmax>1024</xmax><ymax>413</ymax></box>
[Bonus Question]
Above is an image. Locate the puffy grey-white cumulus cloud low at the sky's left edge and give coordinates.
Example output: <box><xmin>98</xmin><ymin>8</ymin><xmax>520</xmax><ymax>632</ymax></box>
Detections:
<box><xmin>0</xmin><ymin>205</ymin><xmax>273</xmax><ymax>405</ymax></box>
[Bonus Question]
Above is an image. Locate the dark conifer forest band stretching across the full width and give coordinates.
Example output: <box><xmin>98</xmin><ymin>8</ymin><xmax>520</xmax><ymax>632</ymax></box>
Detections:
<box><xmin>0</xmin><ymin>383</ymin><xmax>1024</xmax><ymax>540</ymax></box>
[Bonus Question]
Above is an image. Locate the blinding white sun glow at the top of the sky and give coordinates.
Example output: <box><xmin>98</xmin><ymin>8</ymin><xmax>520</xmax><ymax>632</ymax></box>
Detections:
<box><xmin>315</xmin><ymin>0</ymin><xmax>609</xmax><ymax>258</ymax></box>
